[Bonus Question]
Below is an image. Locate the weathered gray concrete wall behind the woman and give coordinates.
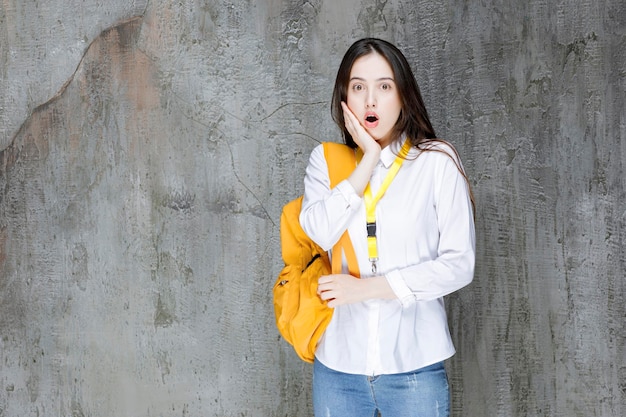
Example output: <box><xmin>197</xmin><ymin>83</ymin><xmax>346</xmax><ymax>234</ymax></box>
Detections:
<box><xmin>0</xmin><ymin>0</ymin><xmax>626</xmax><ymax>417</ymax></box>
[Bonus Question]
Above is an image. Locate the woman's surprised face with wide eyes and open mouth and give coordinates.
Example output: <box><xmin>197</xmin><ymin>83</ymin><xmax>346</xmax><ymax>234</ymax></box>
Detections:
<box><xmin>346</xmin><ymin>52</ymin><xmax>402</xmax><ymax>148</ymax></box>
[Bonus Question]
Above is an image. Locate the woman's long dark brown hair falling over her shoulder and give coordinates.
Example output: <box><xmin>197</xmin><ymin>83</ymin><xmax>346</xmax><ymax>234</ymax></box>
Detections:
<box><xmin>331</xmin><ymin>38</ymin><xmax>476</xmax><ymax>213</ymax></box>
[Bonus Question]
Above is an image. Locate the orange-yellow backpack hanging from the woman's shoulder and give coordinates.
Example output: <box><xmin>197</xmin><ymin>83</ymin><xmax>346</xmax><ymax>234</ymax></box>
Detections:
<box><xmin>273</xmin><ymin>142</ymin><xmax>359</xmax><ymax>362</ymax></box>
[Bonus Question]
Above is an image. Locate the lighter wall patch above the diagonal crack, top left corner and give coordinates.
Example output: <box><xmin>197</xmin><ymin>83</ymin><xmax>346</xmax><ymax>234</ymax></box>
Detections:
<box><xmin>0</xmin><ymin>0</ymin><xmax>148</xmax><ymax>149</ymax></box>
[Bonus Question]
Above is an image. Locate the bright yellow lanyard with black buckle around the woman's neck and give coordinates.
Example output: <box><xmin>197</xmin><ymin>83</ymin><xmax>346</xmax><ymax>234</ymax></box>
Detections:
<box><xmin>359</xmin><ymin>138</ymin><xmax>411</xmax><ymax>274</ymax></box>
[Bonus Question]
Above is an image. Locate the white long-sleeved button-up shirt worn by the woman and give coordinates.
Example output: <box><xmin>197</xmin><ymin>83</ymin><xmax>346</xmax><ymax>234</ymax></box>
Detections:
<box><xmin>300</xmin><ymin>136</ymin><xmax>475</xmax><ymax>375</ymax></box>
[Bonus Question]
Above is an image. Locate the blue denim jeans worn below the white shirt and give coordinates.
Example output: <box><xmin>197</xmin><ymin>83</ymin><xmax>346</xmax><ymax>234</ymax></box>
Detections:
<box><xmin>313</xmin><ymin>359</ymin><xmax>450</xmax><ymax>417</ymax></box>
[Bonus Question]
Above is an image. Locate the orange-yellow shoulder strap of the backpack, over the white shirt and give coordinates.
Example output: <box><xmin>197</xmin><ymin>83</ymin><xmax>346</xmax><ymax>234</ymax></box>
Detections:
<box><xmin>324</xmin><ymin>142</ymin><xmax>361</xmax><ymax>277</ymax></box>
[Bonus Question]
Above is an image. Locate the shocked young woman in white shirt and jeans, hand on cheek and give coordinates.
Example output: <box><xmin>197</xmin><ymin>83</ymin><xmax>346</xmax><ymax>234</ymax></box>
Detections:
<box><xmin>300</xmin><ymin>38</ymin><xmax>475</xmax><ymax>417</ymax></box>
